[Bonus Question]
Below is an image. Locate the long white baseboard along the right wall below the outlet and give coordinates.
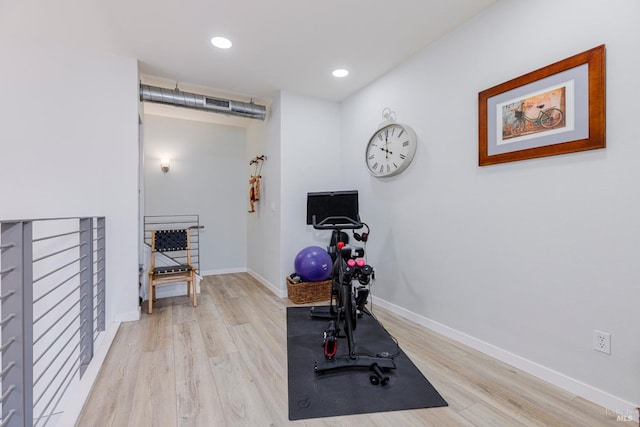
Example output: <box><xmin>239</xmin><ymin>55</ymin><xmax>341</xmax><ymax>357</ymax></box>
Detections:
<box><xmin>372</xmin><ymin>297</ymin><xmax>638</xmax><ymax>422</ymax></box>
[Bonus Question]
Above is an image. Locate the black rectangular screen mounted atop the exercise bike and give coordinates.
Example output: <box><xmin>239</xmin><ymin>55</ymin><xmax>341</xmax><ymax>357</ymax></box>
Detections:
<box><xmin>307</xmin><ymin>190</ymin><xmax>360</xmax><ymax>225</ymax></box>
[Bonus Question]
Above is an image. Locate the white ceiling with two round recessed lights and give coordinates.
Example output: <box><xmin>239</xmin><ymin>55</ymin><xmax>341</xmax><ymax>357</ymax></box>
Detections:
<box><xmin>0</xmin><ymin>0</ymin><xmax>496</xmax><ymax>101</ymax></box>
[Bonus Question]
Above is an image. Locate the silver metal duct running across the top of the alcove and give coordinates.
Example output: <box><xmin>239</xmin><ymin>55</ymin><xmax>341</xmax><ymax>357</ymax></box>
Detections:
<box><xmin>140</xmin><ymin>84</ymin><xmax>267</xmax><ymax>120</ymax></box>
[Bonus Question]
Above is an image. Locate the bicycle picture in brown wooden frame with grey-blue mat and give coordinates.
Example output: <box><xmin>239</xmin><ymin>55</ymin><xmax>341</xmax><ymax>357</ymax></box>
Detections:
<box><xmin>478</xmin><ymin>45</ymin><xmax>605</xmax><ymax>166</ymax></box>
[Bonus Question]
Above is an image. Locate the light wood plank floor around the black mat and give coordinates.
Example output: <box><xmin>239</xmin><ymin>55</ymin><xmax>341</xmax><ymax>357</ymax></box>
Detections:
<box><xmin>78</xmin><ymin>274</ymin><xmax>620</xmax><ymax>427</ymax></box>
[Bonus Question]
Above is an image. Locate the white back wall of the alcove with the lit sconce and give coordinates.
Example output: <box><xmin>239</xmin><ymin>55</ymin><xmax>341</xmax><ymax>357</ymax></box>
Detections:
<box><xmin>144</xmin><ymin>114</ymin><xmax>249</xmax><ymax>274</ymax></box>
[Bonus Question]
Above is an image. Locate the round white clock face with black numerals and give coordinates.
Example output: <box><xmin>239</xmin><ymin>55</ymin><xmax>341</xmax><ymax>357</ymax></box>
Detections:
<box><xmin>365</xmin><ymin>123</ymin><xmax>417</xmax><ymax>177</ymax></box>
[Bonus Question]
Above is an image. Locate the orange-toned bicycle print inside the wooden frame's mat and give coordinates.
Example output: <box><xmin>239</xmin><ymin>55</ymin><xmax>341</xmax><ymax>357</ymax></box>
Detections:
<box><xmin>502</xmin><ymin>87</ymin><xmax>566</xmax><ymax>140</ymax></box>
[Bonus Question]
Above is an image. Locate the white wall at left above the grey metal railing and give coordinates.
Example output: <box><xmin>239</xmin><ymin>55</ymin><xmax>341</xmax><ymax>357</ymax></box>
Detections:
<box><xmin>0</xmin><ymin>44</ymin><xmax>138</xmax><ymax>323</ymax></box>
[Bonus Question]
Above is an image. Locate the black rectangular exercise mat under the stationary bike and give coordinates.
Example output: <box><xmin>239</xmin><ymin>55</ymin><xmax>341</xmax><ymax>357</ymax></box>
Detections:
<box><xmin>287</xmin><ymin>307</ymin><xmax>447</xmax><ymax>420</ymax></box>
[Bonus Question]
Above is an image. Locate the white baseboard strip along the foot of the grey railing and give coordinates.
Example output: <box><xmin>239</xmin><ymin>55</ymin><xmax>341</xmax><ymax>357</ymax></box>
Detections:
<box><xmin>56</xmin><ymin>322</ymin><xmax>120</xmax><ymax>427</ymax></box>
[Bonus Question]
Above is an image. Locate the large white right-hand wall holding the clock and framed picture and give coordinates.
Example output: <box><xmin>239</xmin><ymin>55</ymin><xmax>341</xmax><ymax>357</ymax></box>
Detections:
<box><xmin>342</xmin><ymin>0</ymin><xmax>640</xmax><ymax>410</ymax></box>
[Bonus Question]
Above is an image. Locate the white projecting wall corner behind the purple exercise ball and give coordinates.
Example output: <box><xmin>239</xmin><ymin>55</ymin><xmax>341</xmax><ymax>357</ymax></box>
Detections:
<box><xmin>248</xmin><ymin>92</ymin><xmax>342</xmax><ymax>296</ymax></box>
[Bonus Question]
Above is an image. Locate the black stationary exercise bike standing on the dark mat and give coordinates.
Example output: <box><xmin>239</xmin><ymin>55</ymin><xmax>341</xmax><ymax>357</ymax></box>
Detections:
<box><xmin>310</xmin><ymin>214</ymin><xmax>396</xmax><ymax>385</ymax></box>
